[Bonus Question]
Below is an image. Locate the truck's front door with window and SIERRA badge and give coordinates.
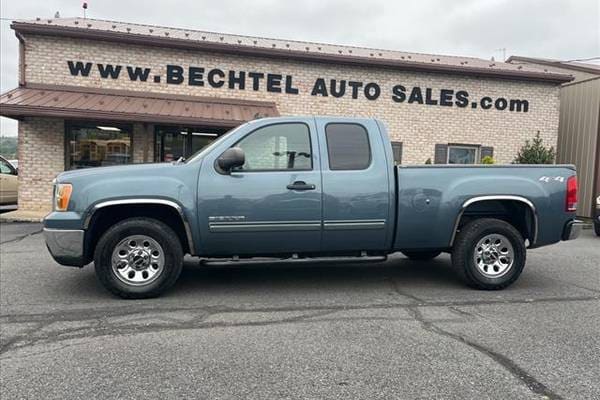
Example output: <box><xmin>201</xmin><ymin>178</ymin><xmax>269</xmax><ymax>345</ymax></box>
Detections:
<box><xmin>198</xmin><ymin>119</ymin><xmax>322</xmax><ymax>255</ymax></box>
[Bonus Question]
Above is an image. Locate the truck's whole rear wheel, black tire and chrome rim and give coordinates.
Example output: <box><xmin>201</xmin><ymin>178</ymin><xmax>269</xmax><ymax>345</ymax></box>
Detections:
<box><xmin>452</xmin><ymin>218</ymin><xmax>526</xmax><ymax>290</ymax></box>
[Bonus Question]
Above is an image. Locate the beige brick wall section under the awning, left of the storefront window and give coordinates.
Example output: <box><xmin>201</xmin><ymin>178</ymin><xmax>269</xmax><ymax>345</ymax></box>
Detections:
<box><xmin>19</xmin><ymin>118</ymin><xmax>65</xmax><ymax>211</ymax></box>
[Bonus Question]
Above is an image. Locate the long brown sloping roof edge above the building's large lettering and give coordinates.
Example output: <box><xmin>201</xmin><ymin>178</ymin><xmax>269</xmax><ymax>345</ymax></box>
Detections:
<box><xmin>11</xmin><ymin>21</ymin><xmax>573</xmax><ymax>84</ymax></box>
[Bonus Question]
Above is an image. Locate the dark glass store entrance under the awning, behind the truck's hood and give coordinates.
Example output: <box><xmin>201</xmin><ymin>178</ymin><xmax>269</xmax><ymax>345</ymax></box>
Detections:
<box><xmin>154</xmin><ymin>125</ymin><xmax>227</xmax><ymax>162</ymax></box>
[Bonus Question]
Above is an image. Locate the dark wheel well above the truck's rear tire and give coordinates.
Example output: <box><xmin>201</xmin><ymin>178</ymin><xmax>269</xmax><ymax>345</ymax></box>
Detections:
<box><xmin>454</xmin><ymin>200</ymin><xmax>537</xmax><ymax>245</ymax></box>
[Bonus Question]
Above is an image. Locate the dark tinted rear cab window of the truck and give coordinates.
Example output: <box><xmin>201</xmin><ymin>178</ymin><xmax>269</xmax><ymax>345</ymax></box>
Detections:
<box><xmin>325</xmin><ymin>123</ymin><xmax>372</xmax><ymax>171</ymax></box>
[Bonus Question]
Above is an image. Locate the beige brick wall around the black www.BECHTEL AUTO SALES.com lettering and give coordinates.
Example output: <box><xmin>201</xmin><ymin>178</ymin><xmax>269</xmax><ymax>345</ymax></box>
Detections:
<box><xmin>16</xmin><ymin>35</ymin><xmax>559</xmax><ymax>211</ymax></box>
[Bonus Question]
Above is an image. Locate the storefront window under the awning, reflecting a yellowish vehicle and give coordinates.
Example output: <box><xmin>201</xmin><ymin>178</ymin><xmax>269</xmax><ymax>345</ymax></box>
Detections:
<box><xmin>66</xmin><ymin>123</ymin><xmax>132</xmax><ymax>169</ymax></box>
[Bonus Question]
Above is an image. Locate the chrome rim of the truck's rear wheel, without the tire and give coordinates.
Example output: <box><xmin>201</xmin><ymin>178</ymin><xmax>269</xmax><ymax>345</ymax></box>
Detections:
<box><xmin>473</xmin><ymin>233</ymin><xmax>515</xmax><ymax>278</ymax></box>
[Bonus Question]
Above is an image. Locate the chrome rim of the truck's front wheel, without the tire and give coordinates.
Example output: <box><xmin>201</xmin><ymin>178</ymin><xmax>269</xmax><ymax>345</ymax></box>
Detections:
<box><xmin>111</xmin><ymin>235</ymin><xmax>165</xmax><ymax>286</ymax></box>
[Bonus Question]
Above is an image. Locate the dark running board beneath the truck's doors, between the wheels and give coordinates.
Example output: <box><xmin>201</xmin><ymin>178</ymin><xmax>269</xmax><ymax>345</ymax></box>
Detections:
<box><xmin>200</xmin><ymin>255</ymin><xmax>387</xmax><ymax>267</ymax></box>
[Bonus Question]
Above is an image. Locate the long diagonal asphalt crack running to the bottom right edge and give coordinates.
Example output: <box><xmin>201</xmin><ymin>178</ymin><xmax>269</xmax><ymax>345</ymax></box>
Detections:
<box><xmin>408</xmin><ymin>306</ymin><xmax>563</xmax><ymax>400</ymax></box>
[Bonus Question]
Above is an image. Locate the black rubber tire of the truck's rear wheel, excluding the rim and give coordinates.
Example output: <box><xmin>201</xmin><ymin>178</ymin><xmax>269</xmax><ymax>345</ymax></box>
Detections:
<box><xmin>452</xmin><ymin>218</ymin><xmax>527</xmax><ymax>290</ymax></box>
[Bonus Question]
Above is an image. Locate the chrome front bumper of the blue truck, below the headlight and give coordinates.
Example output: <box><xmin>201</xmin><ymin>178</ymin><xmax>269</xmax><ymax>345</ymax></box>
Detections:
<box><xmin>44</xmin><ymin>228</ymin><xmax>85</xmax><ymax>267</ymax></box>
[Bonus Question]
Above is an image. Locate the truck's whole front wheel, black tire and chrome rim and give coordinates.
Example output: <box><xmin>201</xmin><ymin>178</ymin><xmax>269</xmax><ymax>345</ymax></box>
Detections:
<box><xmin>94</xmin><ymin>218</ymin><xmax>183</xmax><ymax>299</ymax></box>
